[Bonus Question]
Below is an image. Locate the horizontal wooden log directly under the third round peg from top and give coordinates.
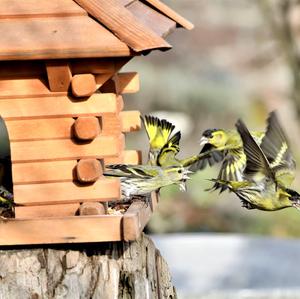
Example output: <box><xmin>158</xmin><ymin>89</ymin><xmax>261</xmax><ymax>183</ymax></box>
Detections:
<box><xmin>14</xmin><ymin>178</ymin><xmax>120</xmax><ymax>205</ymax></box>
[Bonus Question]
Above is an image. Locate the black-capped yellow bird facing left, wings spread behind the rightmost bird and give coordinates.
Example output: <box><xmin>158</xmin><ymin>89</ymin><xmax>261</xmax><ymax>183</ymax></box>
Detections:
<box><xmin>190</xmin><ymin>111</ymin><xmax>295</xmax><ymax>192</ymax></box>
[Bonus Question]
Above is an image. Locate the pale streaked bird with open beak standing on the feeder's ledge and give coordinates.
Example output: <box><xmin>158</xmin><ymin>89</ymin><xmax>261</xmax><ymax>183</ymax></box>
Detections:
<box><xmin>104</xmin><ymin>164</ymin><xmax>190</xmax><ymax>198</ymax></box>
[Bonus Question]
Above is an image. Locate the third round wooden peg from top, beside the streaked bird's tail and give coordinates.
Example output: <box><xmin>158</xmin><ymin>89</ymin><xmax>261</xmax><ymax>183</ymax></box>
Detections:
<box><xmin>76</xmin><ymin>159</ymin><xmax>103</xmax><ymax>183</ymax></box>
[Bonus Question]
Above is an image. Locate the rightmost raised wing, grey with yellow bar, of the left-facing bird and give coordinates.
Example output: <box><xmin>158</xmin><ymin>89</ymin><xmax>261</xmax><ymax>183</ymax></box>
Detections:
<box><xmin>260</xmin><ymin>111</ymin><xmax>296</xmax><ymax>187</ymax></box>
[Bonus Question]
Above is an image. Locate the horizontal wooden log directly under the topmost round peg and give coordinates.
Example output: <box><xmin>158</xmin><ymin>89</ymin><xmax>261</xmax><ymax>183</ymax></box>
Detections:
<box><xmin>0</xmin><ymin>94</ymin><xmax>119</xmax><ymax>120</ymax></box>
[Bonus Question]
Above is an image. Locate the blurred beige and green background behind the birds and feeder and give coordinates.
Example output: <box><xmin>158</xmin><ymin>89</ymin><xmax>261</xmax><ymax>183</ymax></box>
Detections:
<box><xmin>125</xmin><ymin>0</ymin><xmax>300</xmax><ymax>298</ymax></box>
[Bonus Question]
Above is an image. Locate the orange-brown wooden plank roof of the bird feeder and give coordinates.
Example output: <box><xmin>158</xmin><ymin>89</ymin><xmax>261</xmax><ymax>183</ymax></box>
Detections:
<box><xmin>0</xmin><ymin>0</ymin><xmax>193</xmax><ymax>60</ymax></box>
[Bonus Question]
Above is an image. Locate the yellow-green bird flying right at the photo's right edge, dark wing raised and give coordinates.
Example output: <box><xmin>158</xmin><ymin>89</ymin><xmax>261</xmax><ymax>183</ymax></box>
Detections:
<box><xmin>213</xmin><ymin>116</ymin><xmax>300</xmax><ymax>211</ymax></box>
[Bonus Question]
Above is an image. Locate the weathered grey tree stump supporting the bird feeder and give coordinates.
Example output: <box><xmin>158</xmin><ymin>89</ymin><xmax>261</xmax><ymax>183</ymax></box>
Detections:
<box><xmin>0</xmin><ymin>234</ymin><xmax>177</xmax><ymax>299</ymax></box>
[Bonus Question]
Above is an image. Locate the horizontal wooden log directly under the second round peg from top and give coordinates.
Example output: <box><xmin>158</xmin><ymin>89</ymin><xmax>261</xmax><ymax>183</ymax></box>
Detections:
<box><xmin>10</xmin><ymin>136</ymin><xmax>124</xmax><ymax>163</ymax></box>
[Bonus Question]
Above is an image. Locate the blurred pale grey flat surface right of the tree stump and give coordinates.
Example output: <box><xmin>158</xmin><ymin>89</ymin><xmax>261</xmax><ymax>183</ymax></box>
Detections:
<box><xmin>152</xmin><ymin>234</ymin><xmax>300</xmax><ymax>299</ymax></box>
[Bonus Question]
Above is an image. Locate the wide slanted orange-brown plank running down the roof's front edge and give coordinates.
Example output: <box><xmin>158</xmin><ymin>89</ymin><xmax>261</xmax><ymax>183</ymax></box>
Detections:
<box><xmin>75</xmin><ymin>0</ymin><xmax>171</xmax><ymax>52</ymax></box>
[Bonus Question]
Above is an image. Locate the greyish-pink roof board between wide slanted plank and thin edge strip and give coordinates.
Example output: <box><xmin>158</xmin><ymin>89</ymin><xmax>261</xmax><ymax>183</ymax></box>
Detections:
<box><xmin>127</xmin><ymin>1</ymin><xmax>176</xmax><ymax>37</ymax></box>
